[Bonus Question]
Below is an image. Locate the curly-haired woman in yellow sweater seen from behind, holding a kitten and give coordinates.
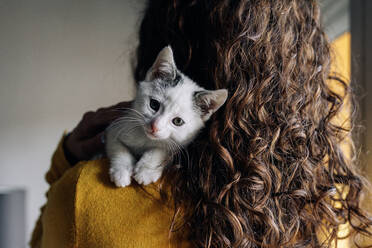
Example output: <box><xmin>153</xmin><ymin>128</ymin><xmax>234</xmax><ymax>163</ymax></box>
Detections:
<box><xmin>31</xmin><ymin>0</ymin><xmax>371</xmax><ymax>247</ymax></box>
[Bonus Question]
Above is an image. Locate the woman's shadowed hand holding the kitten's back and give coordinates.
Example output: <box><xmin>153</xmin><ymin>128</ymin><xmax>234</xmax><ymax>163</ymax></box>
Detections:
<box><xmin>63</xmin><ymin>102</ymin><xmax>131</xmax><ymax>165</ymax></box>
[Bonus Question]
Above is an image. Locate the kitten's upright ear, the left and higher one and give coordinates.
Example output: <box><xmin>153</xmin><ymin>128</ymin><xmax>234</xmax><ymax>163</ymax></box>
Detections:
<box><xmin>146</xmin><ymin>46</ymin><xmax>177</xmax><ymax>81</ymax></box>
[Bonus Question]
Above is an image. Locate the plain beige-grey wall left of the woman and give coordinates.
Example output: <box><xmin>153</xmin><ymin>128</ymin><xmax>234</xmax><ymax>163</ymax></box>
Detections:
<box><xmin>0</xmin><ymin>0</ymin><xmax>143</xmax><ymax>244</ymax></box>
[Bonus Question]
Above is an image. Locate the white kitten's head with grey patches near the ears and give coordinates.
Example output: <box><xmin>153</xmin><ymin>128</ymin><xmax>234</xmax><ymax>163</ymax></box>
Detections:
<box><xmin>134</xmin><ymin>46</ymin><xmax>227</xmax><ymax>145</ymax></box>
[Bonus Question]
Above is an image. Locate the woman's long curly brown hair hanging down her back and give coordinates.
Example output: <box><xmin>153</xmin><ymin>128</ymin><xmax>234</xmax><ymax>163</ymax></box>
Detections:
<box><xmin>134</xmin><ymin>0</ymin><xmax>371</xmax><ymax>247</ymax></box>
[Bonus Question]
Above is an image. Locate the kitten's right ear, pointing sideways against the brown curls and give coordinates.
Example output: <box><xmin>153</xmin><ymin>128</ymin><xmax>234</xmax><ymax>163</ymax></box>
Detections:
<box><xmin>194</xmin><ymin>89</ymin><xmax>228</xmax><ymax>121</ymax></box>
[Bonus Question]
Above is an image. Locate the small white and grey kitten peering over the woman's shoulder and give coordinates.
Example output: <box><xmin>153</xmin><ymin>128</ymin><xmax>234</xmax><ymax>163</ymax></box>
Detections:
<box><xmin>106</xmin><ymin>46</ymin><xmax>227</xmax><ymax>187</ymax></box>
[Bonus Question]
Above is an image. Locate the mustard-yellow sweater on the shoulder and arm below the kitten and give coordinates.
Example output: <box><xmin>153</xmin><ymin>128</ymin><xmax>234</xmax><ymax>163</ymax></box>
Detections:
<box><xmin>30</xmin><ymin>136</ymin><xmax>189</xmax><ymax>248</ymax></box>
